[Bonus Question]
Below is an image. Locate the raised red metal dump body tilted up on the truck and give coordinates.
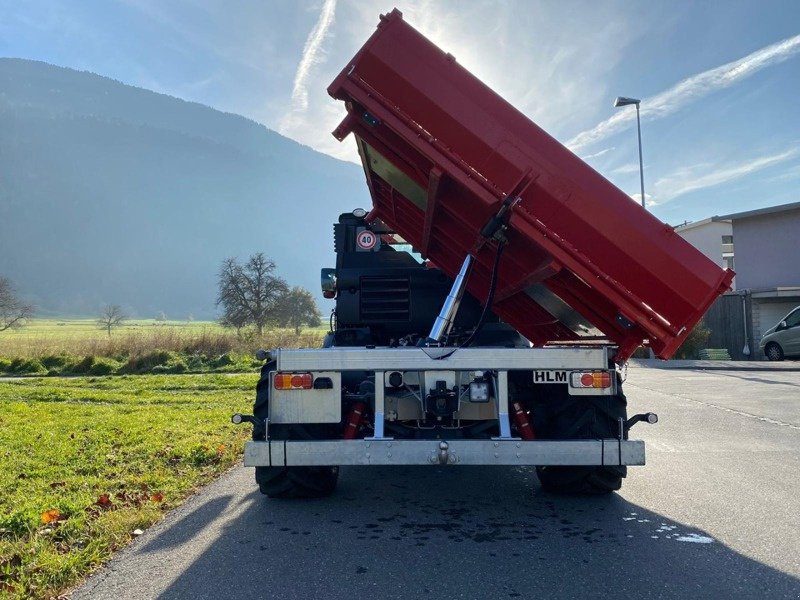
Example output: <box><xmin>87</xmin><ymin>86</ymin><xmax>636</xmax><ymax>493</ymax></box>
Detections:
<box><xmin>328</xmin><ymin>9</ymin><xmax>734</xmax><ymax>362</ymax></box>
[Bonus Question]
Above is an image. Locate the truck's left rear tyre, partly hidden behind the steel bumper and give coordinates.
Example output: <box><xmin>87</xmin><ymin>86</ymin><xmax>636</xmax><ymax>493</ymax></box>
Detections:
<box><xmin>253</xmin><ymin>361</ymin><xmax>339</xmax><ymax>498</ymax></box>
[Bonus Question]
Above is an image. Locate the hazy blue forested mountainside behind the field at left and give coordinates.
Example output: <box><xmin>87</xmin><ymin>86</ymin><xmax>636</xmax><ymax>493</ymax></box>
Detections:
<box><xmin>0</xmin><ymin>59</ymin><xmax>369</xmax><ymax>318</ymax></box>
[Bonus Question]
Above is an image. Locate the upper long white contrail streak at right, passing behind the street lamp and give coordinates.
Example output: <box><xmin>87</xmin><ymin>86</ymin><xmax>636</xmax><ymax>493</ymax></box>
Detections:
<box><xmin>566</xmin><ymin>35</ymin><xmax>800</xmax><ymax>153</ymax></box>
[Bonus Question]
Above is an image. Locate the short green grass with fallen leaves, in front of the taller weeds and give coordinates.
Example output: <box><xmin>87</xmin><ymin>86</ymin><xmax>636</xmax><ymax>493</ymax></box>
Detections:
<box><xmin>0</xmin><ymin>372</ymin><xmax>257</xmax><ymax>599</ymax></box>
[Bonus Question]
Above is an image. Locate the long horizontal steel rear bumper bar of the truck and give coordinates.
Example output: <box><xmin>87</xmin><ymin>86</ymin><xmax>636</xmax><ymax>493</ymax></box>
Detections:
<box><xmin>244</xmin><ymin>439</ymin><xmax>645</xmax><ymax>467</ymax></box>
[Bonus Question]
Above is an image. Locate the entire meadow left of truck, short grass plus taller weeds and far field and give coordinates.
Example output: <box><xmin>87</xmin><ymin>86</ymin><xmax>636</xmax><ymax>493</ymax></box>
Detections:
<box><xmin>0</xmin><ymin>319</ymin><xmax>325</xmax><ymax>599</ymax></box>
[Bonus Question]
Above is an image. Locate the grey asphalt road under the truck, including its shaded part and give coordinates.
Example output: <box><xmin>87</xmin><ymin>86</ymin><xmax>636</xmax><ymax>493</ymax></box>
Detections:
<box><xmin>72</xmin><ymin>368</ymin><xmax>800</xmax><ymax>600</ymax></box>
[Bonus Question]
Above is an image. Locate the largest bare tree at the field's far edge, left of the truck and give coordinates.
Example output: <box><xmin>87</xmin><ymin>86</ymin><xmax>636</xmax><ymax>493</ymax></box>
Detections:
<box><xmin>217</xmin><ymin>252</ymin><xmax>289</xmax><ymax>335</ymax></box>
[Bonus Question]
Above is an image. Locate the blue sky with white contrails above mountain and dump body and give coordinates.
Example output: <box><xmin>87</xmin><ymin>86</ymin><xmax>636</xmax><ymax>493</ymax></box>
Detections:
<box><xmin>0</xmin><ymin>0</ymin><xmax>800</xmax><ymax>224</ymax></box>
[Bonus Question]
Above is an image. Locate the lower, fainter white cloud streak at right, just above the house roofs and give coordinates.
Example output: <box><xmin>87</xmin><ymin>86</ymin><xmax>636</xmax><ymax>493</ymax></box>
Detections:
<box><xmin>654</xmin><ymin>148</ymin><xmax>800</xmax><ymax>204</ymax></box>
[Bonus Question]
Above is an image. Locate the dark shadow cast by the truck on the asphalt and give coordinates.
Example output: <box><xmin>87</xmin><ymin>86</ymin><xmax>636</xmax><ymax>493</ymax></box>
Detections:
<box><xmin>152</xmin><ymin>467</ymin><xmax>800</xmax><ymax>600</ymax></box>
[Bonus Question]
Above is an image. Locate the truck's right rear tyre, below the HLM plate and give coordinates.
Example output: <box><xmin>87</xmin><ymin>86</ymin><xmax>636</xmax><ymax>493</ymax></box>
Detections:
<box><xmin>534</xmin><ymin>387</ymin><xmax>628</xmax><ymax>495</ymax></box>
